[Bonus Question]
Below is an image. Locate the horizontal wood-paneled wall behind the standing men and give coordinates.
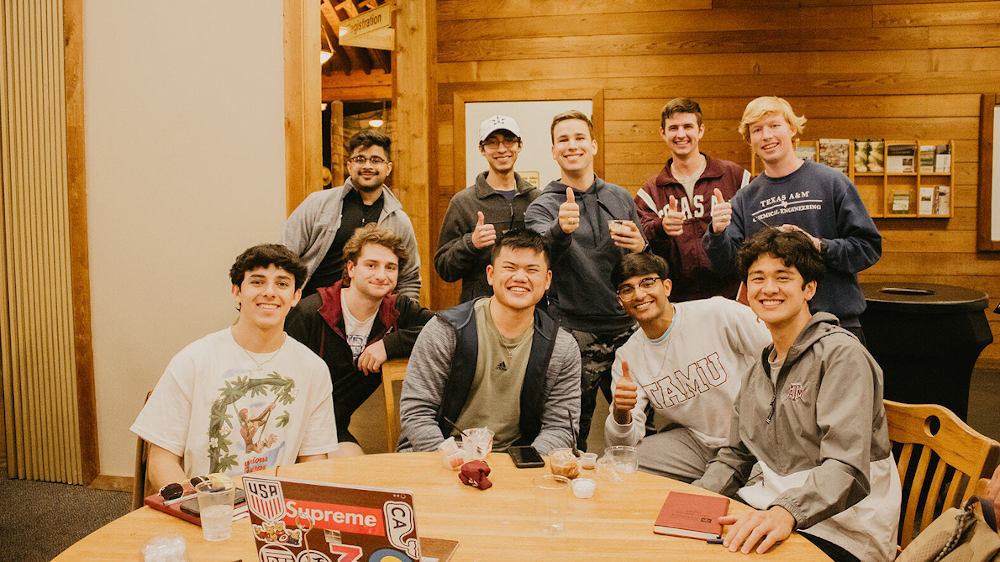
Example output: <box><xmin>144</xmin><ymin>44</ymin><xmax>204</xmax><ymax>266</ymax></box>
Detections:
<box><xmin>431</xmin><ymin>0</ymin><xmax>1000</xmax><ymax>360</ymax></box>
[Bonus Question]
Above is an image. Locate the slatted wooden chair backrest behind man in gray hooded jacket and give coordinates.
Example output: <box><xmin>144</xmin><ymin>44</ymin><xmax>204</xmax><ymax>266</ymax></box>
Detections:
<box><xmin>885</xmin><ymin>400</ymin><xmax>1000</xmax><ymax>548</ymax></box>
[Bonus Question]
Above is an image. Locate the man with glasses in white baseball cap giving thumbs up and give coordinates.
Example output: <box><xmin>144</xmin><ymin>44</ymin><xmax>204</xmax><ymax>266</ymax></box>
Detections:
<box><xmin>434</xmin><ymin>115</ymin><xmax>541</xmax><ymax>302</ymax></box>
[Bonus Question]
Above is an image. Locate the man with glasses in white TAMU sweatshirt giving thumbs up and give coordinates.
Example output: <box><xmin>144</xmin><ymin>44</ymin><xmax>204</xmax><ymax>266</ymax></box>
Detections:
<box><xmin>604</xmin><ymin>253</ymin><xmax>771</xmax><ymax>482</ymax></box>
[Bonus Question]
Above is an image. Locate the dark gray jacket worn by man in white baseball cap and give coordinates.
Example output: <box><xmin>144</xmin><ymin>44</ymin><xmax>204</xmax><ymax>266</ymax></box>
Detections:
<box><xmin>434</xmin><ymin>172</ymin><xmax>542</xmax><ymax>302</ymax></box>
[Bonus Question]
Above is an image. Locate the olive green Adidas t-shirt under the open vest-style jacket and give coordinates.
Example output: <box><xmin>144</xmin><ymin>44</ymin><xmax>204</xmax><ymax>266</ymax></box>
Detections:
<box><xmin>453</xmin><ymin>299</ymin><xmax>534</xmax><ymax>451</ymax></box>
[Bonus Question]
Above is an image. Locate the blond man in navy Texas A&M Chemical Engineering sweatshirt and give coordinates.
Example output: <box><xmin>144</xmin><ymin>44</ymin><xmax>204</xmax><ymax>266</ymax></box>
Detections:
<box><xmin>702</xmin><ymin>96</ymin><xmax>882</xmax><ymax>343</ymax></box>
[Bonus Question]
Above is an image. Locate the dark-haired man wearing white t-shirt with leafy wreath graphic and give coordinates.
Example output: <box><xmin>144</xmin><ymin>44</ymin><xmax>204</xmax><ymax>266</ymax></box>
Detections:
<box><xmin>130</xmin><ymin>244</ymin><xmax>337</xmax><ymax>487</ymax></box>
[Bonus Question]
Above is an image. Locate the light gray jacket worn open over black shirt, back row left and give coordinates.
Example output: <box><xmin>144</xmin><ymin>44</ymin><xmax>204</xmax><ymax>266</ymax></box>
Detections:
<box><xmin>281</xmin><ymin>182</ymin><xmax>420</xmax><ymax>301</ymax></box>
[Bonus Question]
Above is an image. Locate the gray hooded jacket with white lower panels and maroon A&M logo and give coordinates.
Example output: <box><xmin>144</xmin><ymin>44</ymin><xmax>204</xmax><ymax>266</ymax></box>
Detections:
<box><xmin>693</xmin><ymin>312</ymin><xmax>901</xmax><ymax>560</ymax></box>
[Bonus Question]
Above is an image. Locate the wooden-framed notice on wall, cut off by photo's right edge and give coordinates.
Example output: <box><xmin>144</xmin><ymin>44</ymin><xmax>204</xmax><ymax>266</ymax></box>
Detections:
<box><xmin>976</xmin><ymin>94</ymin><xmax>1000</xmax><ymax>252</ymax></box>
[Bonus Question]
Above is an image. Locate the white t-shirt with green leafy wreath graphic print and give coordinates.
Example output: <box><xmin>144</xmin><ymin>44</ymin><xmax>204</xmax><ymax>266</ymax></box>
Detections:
<box><xmin>129</xmin><ymin>328</ymin><xmax>337</xmax><ymax>476</ymax></box>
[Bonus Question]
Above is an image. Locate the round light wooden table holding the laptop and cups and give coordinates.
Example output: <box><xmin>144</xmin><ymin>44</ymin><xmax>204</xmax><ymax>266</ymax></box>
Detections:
<box><xmin>56</xmin><ymin>453</ymin><xmax>826</xmax><ymax>562</ymax></box>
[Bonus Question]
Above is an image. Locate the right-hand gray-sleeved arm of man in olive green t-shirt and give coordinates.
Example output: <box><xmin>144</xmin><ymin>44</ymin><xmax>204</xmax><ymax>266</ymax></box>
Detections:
<box><xmin>531</xmin><ymin>329</ymin><xmax>580</xmax><ymax>455</ymax></box>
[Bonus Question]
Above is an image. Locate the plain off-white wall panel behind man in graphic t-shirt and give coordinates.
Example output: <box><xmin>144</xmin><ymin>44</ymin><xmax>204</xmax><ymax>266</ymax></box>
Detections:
<box><xmin>83</xmin><ymin>0</ymin><xmax>285</xmax><ymax>475</ymax></box>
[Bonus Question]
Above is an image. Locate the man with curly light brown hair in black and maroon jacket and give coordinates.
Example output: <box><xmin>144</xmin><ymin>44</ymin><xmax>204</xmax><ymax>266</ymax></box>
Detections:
<box><xmin>285</xmin><ymin>223</ymin><xmax>433</xmax><ymax>456</ymax></box>
